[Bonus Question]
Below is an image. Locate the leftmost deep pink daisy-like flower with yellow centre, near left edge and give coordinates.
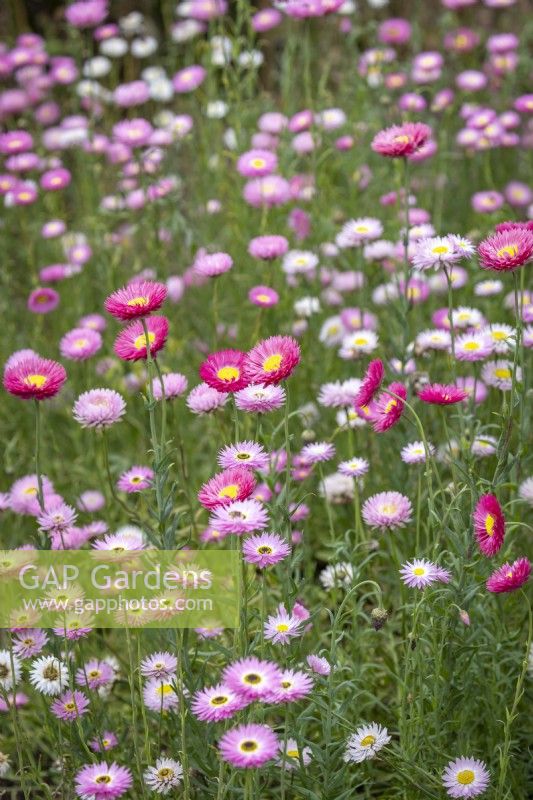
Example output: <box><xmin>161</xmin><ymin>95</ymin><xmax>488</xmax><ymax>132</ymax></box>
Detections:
<box><xmin>4</xmin><ymin>355</ymin><xmax>67</xmax><ymax>400</ymax></box>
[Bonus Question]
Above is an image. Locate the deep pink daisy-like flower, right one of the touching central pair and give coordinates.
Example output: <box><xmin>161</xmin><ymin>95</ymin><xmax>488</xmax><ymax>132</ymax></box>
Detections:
<box><xmin>244</xmin><ymin>336</ymin><xmax>300</xmax><ymax>386</ymax></box>
